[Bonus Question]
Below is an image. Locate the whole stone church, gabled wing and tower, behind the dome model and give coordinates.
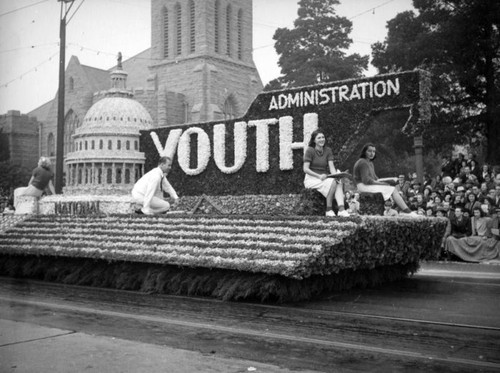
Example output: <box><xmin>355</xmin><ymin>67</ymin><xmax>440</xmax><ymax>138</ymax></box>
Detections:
<box><xmin>28</xmin><ymin>0</ymin><xmax>263</xmax><ymax>180</ymax></box>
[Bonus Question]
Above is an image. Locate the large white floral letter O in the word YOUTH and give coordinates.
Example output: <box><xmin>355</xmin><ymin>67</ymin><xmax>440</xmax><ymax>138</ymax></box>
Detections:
<box><xmin>177</xmin><ymin>127</ymin><xmax>210</xmax><ymax>176</ymax></box>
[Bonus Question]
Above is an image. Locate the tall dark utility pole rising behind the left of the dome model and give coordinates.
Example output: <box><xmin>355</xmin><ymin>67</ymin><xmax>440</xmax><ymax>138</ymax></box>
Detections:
<box><xmin>55</xmin><ymin>0</ymin><xmax>74</xmax><ymax>194</ymax></box>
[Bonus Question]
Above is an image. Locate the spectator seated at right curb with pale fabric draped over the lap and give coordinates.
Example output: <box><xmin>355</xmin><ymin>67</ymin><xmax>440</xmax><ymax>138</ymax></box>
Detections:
<box><xmin>446</xmin><ymin>207</ymin><xmax>500</xmax><ymax>262</ymax></box>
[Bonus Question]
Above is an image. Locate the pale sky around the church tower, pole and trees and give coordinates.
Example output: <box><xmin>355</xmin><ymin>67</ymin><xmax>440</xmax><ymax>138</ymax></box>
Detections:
<box><xmin>0</xmin><ymin>0</ymin><xmax>413</xmax><ymax>114</ymax></box>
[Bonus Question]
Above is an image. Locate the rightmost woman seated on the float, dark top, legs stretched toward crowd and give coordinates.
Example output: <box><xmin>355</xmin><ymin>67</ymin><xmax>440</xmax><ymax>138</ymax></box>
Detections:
<box><xmin>353</xmin><ymin>144</ymin><xmax>411</xmax><ymax>214</ymax></box>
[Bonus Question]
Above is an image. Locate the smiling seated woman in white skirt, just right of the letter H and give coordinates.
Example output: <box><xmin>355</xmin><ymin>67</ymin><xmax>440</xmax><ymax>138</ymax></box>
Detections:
<box><xmin>303</xmin><ymin>129</ymin><xmax>349</xmax><ymax>216</ymax></box>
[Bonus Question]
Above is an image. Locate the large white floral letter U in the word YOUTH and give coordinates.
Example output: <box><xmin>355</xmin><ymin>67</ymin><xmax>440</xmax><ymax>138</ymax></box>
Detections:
<box><xmin>214</xmin><ymin>122</ymin><xmax>247</xmax><ymax>174</ymax></box>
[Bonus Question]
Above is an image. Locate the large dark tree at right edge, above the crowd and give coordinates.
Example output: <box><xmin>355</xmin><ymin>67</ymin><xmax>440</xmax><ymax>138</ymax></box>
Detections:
<box><xmin>372</xmin><ymin>0</ymin><xmax>500</xmax><ymax>164</ymax></box>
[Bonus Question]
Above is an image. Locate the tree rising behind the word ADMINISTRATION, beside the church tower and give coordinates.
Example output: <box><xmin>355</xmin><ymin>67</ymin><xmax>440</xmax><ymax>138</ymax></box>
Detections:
<box><xmin>265</xmin><ymin>0</ymin><xmax>368</xmax><ymax>90</ymax></box>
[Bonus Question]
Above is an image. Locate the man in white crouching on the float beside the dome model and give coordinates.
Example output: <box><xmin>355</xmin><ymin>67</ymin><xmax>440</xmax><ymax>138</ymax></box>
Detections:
<box><xmin>132</xmin><ymin>157</ymin><xmax>179</xmax><ymax>215</ymax></box>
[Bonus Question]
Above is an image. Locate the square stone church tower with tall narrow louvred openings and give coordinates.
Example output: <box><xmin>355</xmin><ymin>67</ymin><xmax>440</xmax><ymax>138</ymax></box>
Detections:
<box><xmin>148</xmin><ymin>0</ymin><xmax>263</xmax><ymax>126</ymax></box>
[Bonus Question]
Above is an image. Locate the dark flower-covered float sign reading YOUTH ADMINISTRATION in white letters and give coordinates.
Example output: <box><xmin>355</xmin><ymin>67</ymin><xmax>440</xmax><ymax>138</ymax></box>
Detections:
<box><xmin>140</xmin><ymin>71</ymin><xmax>430</xmax><ymax>196</ymax></box>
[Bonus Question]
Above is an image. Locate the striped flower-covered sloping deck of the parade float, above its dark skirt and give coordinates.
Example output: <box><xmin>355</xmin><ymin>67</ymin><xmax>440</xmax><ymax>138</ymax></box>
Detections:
<box><xmin>0</xmin><ymin>215</ymin><xmax>446</xmax><ymax>279</ymax></box>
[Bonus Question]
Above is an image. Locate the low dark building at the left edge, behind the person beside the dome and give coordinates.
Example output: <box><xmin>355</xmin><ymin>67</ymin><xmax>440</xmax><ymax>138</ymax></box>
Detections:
<box><xmin>0</xmin><ymin>110</ymin><xmax>39</xmax><ymax>169</ymax></box>
